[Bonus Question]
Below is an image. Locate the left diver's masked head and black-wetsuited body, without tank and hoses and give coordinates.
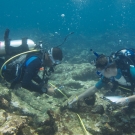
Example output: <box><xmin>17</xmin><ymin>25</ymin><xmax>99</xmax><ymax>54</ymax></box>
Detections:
<box><xmin>8</xmin><ymin>47</ymin><xmax>63</xmax><ymax>94</ymax></box>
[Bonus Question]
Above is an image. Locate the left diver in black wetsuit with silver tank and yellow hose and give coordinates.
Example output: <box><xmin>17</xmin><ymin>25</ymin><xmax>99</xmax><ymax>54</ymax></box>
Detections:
<box><xmin>0</xmin><ymin>29</ymin><xmax>73</xmax><ymax>94</ymax></box>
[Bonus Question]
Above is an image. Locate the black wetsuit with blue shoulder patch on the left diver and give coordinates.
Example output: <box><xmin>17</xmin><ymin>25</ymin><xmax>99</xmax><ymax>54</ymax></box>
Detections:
<box><xmin>10</xmin><ymin>56</ymin><xmax>44</xmax><ymax>94</ymax></box>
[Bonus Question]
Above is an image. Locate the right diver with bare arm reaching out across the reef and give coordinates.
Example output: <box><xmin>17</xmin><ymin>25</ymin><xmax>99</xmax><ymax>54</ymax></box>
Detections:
<box><xmin>64</xmin><ymin>49</ymin><xmax>135</xmax><ymax>108</ymax></box>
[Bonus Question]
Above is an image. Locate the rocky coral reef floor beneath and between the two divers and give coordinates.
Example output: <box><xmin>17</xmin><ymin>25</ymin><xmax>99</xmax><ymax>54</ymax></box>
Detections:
<box><xmin>0</xmin><ymin>62</ymin><xmax>135</xmax><ymax>135</ymax></box>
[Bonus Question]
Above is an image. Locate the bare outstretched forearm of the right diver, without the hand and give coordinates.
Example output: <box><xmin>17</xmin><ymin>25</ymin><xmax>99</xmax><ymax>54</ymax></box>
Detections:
<box><xmin>78</xmin><ymin>86</ymin><xmax>98</xmax><ymax>99</ymax></box>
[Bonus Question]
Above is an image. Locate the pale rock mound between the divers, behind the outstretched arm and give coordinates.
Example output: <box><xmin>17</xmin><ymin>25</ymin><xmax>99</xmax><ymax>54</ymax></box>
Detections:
<box><xmin>47</xmin><ymin>63</ymin><xmax>97</xmax><ymax>97</ymax></box>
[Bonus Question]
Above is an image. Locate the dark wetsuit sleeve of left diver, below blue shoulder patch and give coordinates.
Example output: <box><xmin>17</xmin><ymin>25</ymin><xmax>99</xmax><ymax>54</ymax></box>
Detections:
<box><xmin>22</xmin><ymin>58</ymin><xmax>42</xmax><ymax>93</ymax></box>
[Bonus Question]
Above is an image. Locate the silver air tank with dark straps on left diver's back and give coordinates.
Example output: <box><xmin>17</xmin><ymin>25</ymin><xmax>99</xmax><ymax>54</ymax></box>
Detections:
<box><xmin>0</xmin><ymin>38</ymin><xmax>36</xmax><ymax>56</ymax></box>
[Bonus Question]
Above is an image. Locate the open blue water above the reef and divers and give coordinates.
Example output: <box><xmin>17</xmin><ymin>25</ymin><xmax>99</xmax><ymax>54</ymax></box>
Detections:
<box><xmin>0</xmin><ymin>0</ymin><xmax>135</xmax><ymax>53</ymax></box>
